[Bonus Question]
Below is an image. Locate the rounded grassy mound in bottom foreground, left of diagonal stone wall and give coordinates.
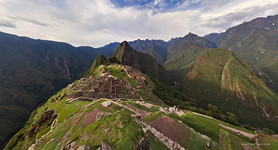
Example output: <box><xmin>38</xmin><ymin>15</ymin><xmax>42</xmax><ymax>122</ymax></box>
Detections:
<box><xmin>70</xmin><ymin>110</ymin><xmax>144</xmax><ymax>150</ymax></box>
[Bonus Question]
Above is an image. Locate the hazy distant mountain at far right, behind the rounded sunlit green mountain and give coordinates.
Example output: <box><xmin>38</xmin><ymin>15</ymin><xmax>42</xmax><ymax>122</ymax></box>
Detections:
<box><xmin>215</xmin><ymin>15</ymin><xmax>278</xmax><ymax>92</ymax></box>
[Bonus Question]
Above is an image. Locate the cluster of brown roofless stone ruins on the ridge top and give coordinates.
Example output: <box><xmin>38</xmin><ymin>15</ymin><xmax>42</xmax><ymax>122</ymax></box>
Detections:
<box><xmin>68</xmin><ymin>66</ymin><xmax>146</xmax><ymax>99</ymax></box>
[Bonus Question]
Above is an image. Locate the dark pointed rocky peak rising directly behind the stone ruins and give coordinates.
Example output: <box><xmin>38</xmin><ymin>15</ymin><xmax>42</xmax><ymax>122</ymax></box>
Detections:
<box><xmin>112</xmin><ymin>41</ymin><xmax>172</xmax><ymax>85</ymax></box>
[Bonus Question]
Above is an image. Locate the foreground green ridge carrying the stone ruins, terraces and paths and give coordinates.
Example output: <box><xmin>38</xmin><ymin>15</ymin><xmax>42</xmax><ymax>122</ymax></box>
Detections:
<box><xmin>8</xmin><ymin>60</ymin><xmax>272</xmax><ymax>150</ymax></box>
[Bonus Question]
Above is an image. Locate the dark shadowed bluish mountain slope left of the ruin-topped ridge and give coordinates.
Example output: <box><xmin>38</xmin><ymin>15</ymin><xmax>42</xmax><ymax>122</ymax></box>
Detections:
<box><xmin>0</xmin><ymin>32</ymin><xmax>97</xmax><ymax>148</ymax></box>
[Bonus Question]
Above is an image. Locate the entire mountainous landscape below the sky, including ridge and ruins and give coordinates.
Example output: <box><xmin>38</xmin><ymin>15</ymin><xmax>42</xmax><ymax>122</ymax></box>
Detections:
<box><xmin>0</xmin><ymin>15</ymin><xmax>278</xmax><ymax>150</ymax></box>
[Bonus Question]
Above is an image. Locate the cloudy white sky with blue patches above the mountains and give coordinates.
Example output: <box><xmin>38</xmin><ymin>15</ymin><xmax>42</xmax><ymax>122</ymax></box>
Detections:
<box><xmin>0</xmin><ymin>0</ymin><xmax>278</xmax><ymax>47</ymax></box>
